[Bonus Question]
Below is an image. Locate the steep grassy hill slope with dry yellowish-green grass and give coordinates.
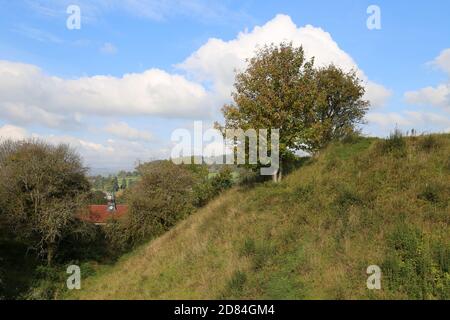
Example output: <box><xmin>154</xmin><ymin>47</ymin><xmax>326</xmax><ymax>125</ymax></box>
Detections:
<box><xmin>67</xmin><ymin>135</ymin><xmax>450</xmax><ymax>299</ymax></box>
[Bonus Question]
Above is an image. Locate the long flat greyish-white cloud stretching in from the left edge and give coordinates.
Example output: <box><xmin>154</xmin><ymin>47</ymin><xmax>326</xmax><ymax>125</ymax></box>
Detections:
<box><xmin>0</xmin><ymin>61</ymin><xmax>211</xmax><ymax>126</ymax></box>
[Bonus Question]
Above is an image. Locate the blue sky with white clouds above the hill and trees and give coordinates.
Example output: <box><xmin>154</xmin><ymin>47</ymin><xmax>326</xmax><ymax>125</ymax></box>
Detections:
<box><xmin>0</xmin><ymin>0</ymin><xmax>450</xmax><ymax>172</ymax></box>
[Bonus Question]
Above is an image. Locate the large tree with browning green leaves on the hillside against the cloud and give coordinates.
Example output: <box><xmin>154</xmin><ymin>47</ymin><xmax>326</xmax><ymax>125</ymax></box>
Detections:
<box><xmin>222</xmin><ymin>43</ymin><xmax>369</xmax><ymax>180</ymax></box>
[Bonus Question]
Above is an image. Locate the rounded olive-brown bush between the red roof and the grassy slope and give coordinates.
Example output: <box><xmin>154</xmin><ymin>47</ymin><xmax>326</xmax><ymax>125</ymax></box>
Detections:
<box><xmin>104</xmin><ymin>161</ymin><xmax>233</xmax><ymax>250</ymax></box>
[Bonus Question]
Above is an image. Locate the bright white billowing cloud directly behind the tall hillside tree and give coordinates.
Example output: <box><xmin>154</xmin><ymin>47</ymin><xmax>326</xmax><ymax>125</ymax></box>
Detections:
<box><xmin>178</xmin><ymin>15</ymin><xmax>391</xmax><ymax>107</ymax></box>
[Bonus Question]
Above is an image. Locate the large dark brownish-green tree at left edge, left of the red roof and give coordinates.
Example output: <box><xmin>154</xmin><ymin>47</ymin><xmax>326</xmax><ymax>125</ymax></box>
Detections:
<box><xmin>0</xmin><ymin>140</ymin><xmax>89</xmax><ymax>264</ymax></box>
